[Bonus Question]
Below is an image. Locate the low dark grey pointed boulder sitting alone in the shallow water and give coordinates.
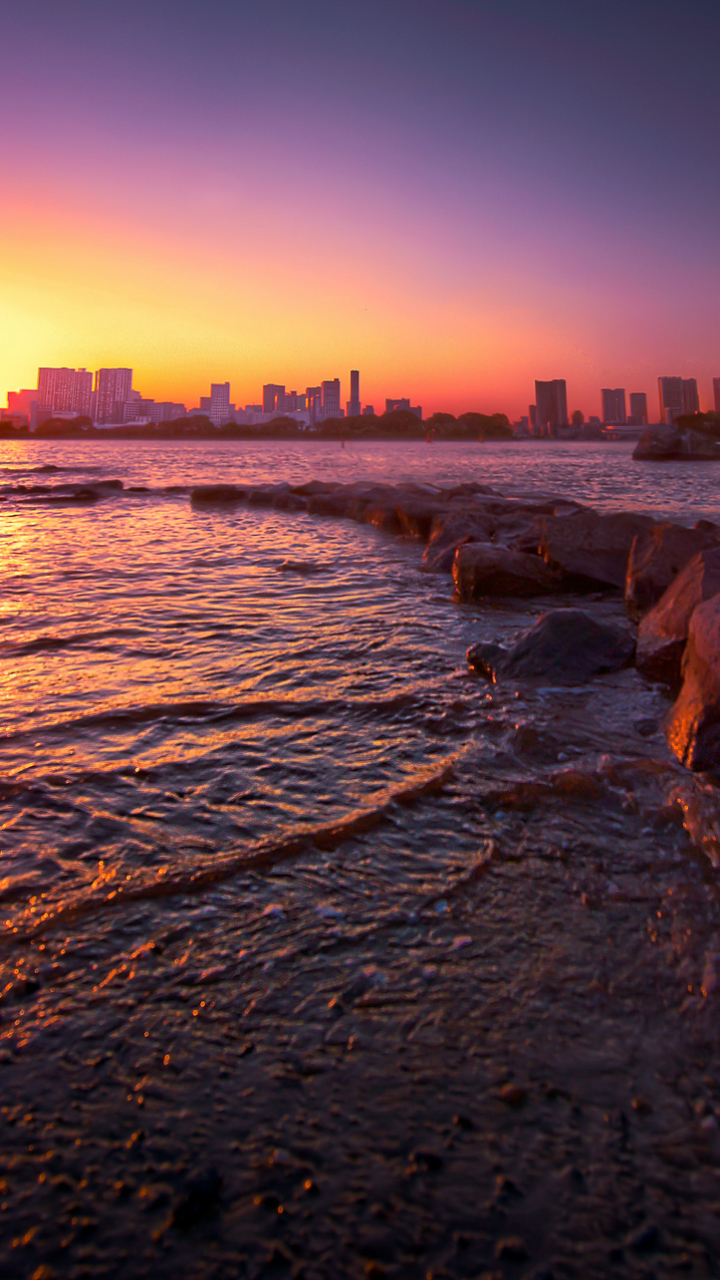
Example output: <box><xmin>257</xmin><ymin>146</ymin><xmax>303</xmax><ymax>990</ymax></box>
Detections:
<box><xmin>468</xmin><ymin>609</ymin><xmax>635</xmax><ymax>685</ymax></box>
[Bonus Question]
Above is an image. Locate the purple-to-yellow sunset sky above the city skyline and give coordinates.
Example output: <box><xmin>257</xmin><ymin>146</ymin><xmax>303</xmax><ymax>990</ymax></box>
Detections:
<box><xmin>0</xmin><ymin>0</ymin><xmax>720</xmax><ymax>417</ymax></box>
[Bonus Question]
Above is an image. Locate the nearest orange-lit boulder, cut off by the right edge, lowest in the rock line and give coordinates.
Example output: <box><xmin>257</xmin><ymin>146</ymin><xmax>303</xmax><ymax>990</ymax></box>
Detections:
<box><xmin>665</xmin><ymin>595</ymin><xmax>720</xmax><ymax>769</ymax></box>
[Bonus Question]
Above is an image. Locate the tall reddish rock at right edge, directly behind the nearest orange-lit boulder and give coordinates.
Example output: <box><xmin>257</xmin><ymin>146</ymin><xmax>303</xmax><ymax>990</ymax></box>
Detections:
<box><xmin>635</xmin><ymin>547</ymin><xmax>720</xmax><ymax>685</ymax></box>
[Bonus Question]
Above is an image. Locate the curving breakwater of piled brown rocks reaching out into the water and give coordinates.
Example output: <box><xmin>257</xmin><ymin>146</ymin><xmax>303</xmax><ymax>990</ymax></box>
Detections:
<box><xmin>191</xmin><ymin>480</ymin><xmax>720</xmax><ymax>769</ymax></box>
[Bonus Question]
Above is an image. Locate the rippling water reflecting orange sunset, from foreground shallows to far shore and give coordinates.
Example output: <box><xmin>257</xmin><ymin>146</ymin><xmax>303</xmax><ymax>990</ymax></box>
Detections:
<box><xmin>0</xmin><ymin>442</ymin><xmax>720</xmax><ymax>1280</ymax></box>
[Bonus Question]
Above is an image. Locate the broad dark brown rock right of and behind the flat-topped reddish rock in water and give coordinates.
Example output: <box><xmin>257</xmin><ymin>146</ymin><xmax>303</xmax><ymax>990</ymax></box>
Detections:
<box><xmin>537</xmin><ymin>511</ymin><xmax>655</xmax><ymax>590</ymax></box>
